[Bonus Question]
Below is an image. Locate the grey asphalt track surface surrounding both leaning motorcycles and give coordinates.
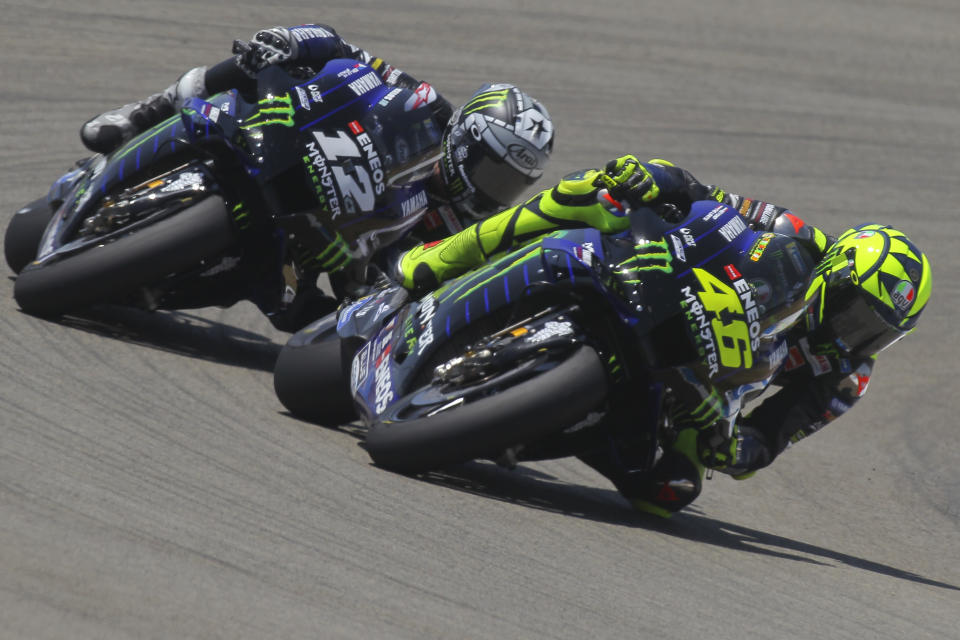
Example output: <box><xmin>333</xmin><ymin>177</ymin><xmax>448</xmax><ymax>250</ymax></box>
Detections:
<box><xmin>0</xmin><ymin>0</ymin><xmax>960</xmax><ymax>640</ymax></box>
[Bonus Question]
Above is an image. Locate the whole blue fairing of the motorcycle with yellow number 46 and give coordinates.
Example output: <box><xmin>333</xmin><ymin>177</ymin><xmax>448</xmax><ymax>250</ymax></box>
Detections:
<box><xmin>344</xmin><ymin>201</ymin><xmax>814</xmax><ymax>417</ymax></box>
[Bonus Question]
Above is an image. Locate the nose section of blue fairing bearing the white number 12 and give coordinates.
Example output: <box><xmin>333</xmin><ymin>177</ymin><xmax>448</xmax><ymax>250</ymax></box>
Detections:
<box><xmin>290</xmin><ymin>60</ymin><xmax>442</xmax><ymax>255</ymax></box>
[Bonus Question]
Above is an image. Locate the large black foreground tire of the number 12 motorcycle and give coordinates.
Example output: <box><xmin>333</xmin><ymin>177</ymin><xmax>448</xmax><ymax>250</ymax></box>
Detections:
<box><xmin>13</xmin><ymin>196</ymin><xmax>235</xmax><ymax>316</ymax></box>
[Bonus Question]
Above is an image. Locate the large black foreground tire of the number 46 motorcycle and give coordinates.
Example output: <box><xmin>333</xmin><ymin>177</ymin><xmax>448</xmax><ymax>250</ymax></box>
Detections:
<box><xmin>365</xmin><ymin>346</ymin><xmax>607</xmax><ymax>474</ymax></box>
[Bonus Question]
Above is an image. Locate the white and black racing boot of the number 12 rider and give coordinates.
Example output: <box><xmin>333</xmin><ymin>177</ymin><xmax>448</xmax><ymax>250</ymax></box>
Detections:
<box><xmin>80</xmin><ymin>67</ymin><xmax>207</xmax><ymax>153</ymax></box>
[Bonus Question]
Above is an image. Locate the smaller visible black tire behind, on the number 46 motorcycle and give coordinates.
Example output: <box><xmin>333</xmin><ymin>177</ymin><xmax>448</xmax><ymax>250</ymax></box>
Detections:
<box><xmin>273</xmin><ymin>333</ymin><xmax>357</xmax><ymax>427</ymax></box>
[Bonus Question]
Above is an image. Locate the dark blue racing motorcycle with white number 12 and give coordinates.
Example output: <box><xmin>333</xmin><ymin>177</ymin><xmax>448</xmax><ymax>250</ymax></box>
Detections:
<box><xmin>4</xmin><ymin>59</ymin><xmax>450</xmax><ymax>319</ymax></box>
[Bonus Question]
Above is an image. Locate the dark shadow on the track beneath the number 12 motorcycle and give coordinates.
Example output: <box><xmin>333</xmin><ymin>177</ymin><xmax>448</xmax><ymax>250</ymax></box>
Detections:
<box><xmin>25</xmin><ymin>305</ymin><xmax>282</xmax><ymax>373</ymax></box>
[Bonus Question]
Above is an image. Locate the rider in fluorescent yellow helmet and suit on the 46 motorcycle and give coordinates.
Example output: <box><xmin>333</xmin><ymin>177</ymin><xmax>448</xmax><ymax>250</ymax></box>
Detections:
<box><xmin>395</xmin><ymin>155</ymin><xmax>931</xmax><ymax>517</ymax></box>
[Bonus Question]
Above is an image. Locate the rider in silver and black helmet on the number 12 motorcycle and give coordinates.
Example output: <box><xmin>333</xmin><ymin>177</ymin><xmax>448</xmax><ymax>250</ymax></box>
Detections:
<box><xmin>80</xmin><ymin>24</ymin><xmax>554</xmax><ymax>330</ymax></box>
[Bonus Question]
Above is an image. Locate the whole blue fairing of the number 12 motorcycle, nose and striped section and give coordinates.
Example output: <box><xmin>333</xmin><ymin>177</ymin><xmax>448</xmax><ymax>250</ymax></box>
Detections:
<box><xmin>32</xmin><ymin>60</ymin><xmax>441</xmax><ymax>270</ymax></box>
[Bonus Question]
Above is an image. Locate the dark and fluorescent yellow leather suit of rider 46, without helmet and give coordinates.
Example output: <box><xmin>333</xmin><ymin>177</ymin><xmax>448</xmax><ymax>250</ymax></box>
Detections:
<box><xmin>396</xmin><ymin>156</ymin><xmax>874</xmax><ymax>516</ymax></box>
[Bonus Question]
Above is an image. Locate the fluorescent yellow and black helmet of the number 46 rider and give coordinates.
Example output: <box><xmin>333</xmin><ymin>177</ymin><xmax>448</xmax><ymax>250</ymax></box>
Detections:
<box><xmin>806</xmin><ymin>224</ymin><xmax>932</xmax><ymax>357</ymax></box>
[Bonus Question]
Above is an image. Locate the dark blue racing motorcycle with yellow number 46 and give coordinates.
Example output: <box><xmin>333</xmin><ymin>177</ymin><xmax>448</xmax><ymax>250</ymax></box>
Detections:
<box><xmin>274</xmin><ymin>201</ymin><xmax>816</xmax><ymax>473</ymax></box>
